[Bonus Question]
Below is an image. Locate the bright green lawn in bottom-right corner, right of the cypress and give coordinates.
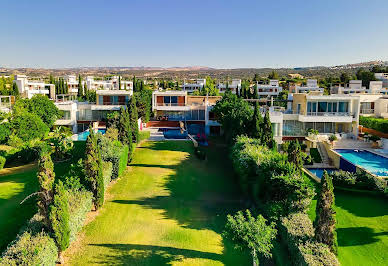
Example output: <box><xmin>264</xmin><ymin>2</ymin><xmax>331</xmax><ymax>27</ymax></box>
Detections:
<box><xmin>309</xmin><ymin>186</ymin><xmax>388</xmax><ymax>265</ymax></box>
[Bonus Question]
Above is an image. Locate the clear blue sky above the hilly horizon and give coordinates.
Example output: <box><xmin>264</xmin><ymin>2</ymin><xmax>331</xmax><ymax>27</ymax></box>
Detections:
<box><xmin>0</xmin><ymin>0</ymin><xmax>388</xmax><ymax>68</ymax></box>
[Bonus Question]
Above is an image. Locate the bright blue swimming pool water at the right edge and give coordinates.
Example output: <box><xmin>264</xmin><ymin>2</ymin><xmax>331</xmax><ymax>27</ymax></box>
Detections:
<box><xmin>335</xmin><ymin>149</ymin><xmax>388</xmax><ymax>176</ymax></box>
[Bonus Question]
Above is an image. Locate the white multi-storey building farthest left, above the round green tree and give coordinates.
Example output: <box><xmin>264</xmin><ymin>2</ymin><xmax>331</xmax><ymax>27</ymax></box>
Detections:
<box><xmin>13</xmin><ymin>75</ymin><xmax>55</xmax><ymax>99</ymax></box>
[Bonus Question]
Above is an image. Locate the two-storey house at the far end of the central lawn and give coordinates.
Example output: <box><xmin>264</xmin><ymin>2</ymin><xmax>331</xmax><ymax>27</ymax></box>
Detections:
<box><xmin>150</xmin><ymin>91</ymin><xmax>221</xmax><ymax>134</ymax></box>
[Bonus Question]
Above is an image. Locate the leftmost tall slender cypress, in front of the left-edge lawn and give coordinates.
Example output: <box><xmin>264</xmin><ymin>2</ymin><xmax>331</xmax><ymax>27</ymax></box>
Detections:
<box><xmin>37</xmin><ymin>146</ymin><xmax>55</xmax><ymax>228</ymax></box>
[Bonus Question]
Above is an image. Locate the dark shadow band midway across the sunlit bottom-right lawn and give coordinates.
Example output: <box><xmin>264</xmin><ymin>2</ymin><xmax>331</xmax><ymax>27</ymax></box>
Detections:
<box><xmin>337</xmin><ymin>227</ymin><xmax>388</xmax><ymax>247</ymax></box>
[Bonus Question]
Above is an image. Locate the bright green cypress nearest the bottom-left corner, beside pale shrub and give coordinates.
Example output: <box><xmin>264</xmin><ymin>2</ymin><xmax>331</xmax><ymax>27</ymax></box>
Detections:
<box><xmin>50</xmin><ymin>181</ymin><xmax>70</xmax><ymax>254</ymax></box>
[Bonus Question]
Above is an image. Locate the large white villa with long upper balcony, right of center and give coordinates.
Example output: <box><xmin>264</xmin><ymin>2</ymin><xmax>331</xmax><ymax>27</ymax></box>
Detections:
<box><xmin>269</xmin><ymin>92</ymin><xmax>360</xmax><ymax>143</ymax></box>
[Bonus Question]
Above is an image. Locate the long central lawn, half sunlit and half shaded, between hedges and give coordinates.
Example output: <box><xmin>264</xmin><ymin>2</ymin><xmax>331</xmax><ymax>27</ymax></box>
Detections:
<box><xmin>65</xmin><ymin>141</ymin><xmax>251</xmax><ymax>265</ymax></box>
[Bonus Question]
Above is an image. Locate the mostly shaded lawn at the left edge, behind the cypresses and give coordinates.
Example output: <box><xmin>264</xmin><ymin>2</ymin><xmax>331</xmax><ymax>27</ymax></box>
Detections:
<box><xmin>0</xmin><ymin>142</ymin><xmax>85</xmax><ymax>253</ymax></box>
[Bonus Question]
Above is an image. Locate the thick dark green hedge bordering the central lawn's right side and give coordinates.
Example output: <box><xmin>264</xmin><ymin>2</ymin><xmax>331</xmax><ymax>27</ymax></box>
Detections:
<box><xmin>231</xmin><ymin>136</ymin><xmax>314</xmax><ymax>214</ymax></box>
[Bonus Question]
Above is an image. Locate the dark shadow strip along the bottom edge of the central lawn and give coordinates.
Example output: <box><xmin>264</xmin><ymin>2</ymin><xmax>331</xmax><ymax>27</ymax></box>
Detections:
<box><xmin>87</xmin><ymin>244</ymin><xmax>222</xmax><ymax>265</ymax></box>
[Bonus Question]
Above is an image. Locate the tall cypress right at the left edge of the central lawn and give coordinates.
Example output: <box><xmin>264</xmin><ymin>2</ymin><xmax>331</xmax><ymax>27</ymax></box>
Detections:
<box><xmin>85</xmin><ymin>127</ymin><xmax>105</xmax><ymax>210</ymax></box>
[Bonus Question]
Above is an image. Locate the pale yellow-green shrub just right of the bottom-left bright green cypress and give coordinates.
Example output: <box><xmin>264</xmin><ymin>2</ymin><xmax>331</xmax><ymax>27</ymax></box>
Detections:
<box><xmin>69</xmin><ymin>190</ymin><xmax>93</xmax><ymax>242</ymax></box>
